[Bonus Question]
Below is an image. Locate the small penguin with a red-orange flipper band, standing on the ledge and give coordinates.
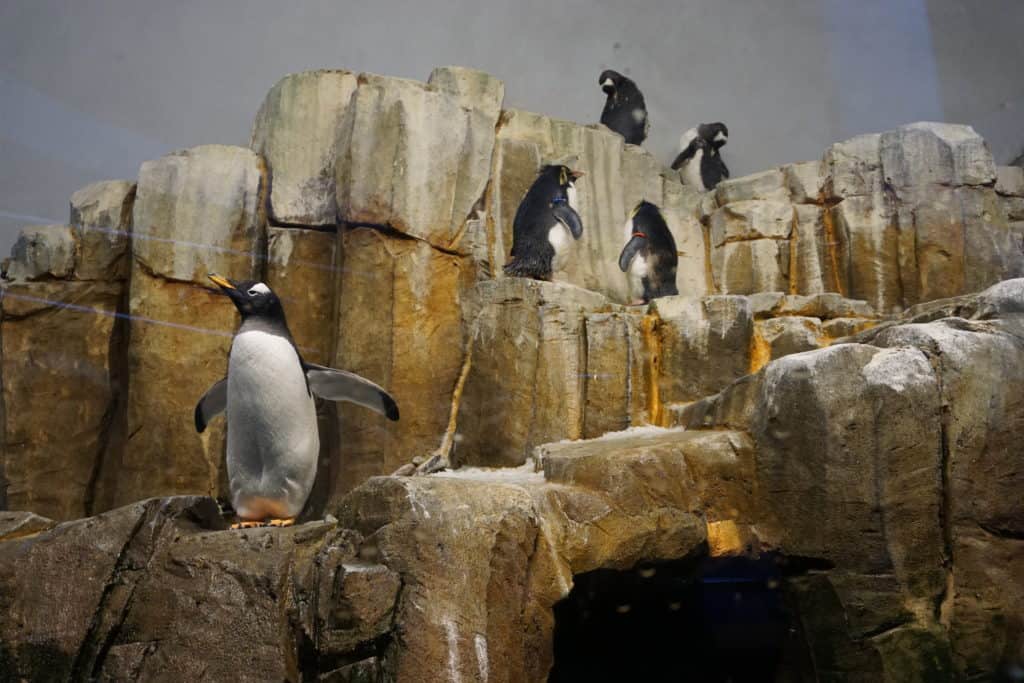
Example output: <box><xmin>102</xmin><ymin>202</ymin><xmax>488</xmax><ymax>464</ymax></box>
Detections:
<box><xmin>618</xmin><ymin>201</ymin><xmax>679</xmax><ymax>303</ymax></box>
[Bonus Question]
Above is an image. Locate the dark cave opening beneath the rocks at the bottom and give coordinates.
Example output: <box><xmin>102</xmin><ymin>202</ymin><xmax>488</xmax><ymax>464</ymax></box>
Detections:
<box><xmin>548</xmin><ymin>554</ymin><xmax>814</xmax><ymax>683</ymax></box>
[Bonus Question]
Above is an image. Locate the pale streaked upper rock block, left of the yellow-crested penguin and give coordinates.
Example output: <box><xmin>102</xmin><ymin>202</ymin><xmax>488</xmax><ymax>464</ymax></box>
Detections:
<box><xmin>337</xmin><ymin>74</ymin><xmax>504</xmax><ymax>250</ymax></box>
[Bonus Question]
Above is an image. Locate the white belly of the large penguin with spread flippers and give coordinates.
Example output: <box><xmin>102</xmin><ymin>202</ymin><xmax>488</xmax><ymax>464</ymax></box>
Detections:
<box><xmin>227</xmin><ymin>328</ymin><xmax>319</xmax><ymax>519</ymax></box>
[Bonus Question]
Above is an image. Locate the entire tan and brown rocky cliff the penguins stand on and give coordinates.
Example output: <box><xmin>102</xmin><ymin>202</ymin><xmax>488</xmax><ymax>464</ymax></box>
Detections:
<box><xmin>0</xmin><ymin>68</ymin><xmax>1024</xmax><ymax>681</ymax></box>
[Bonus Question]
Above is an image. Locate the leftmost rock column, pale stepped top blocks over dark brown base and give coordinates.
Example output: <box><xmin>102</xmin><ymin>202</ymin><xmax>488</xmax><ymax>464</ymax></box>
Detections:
<box><xmin>0</xmin><ymin>180</ymin><xmax>135</xmax><ymax>519</ymax></box>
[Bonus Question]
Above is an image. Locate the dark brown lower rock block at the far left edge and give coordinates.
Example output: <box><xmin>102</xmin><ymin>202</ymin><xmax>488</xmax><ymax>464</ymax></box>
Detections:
<box><xmin>0</xmin><ymin>282</ymin><xmax>121</xmax><ymax>519</ymax></box>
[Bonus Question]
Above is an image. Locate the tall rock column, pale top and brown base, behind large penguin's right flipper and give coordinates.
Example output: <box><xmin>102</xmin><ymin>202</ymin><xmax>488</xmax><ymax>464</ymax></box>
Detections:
<box><xmin>331</xmin><ymin>68</ymin><xmax>504</xmax><ymax>493</ymax></box>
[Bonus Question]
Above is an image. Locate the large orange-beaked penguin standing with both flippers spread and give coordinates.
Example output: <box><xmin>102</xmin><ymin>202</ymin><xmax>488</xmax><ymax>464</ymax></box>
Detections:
<box><xmin>195</xmin><ymin>274</ymin><xmax>398</xmax><ymax>527</ymax></box>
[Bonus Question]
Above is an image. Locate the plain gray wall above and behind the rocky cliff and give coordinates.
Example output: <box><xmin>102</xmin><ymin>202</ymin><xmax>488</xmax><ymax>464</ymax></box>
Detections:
<box><xmin>0</xmin><ymin>0</ymin><xmax>1024</xmax><ymax>254</ymax></box>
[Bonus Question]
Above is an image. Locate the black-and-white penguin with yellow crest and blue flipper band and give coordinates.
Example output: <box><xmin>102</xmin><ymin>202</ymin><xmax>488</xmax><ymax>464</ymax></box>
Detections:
<box><xmin>505</xmin><ymin>165</ymin><xmax>583</xmax><ymax>280</ymax></box>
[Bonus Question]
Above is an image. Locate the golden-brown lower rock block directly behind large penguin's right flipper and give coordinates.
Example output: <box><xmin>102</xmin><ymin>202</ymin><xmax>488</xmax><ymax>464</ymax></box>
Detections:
<box><xmin>332</xmin><ymin>227</ymin><xmax>472</xmax><ymax>493</ymax></box>
